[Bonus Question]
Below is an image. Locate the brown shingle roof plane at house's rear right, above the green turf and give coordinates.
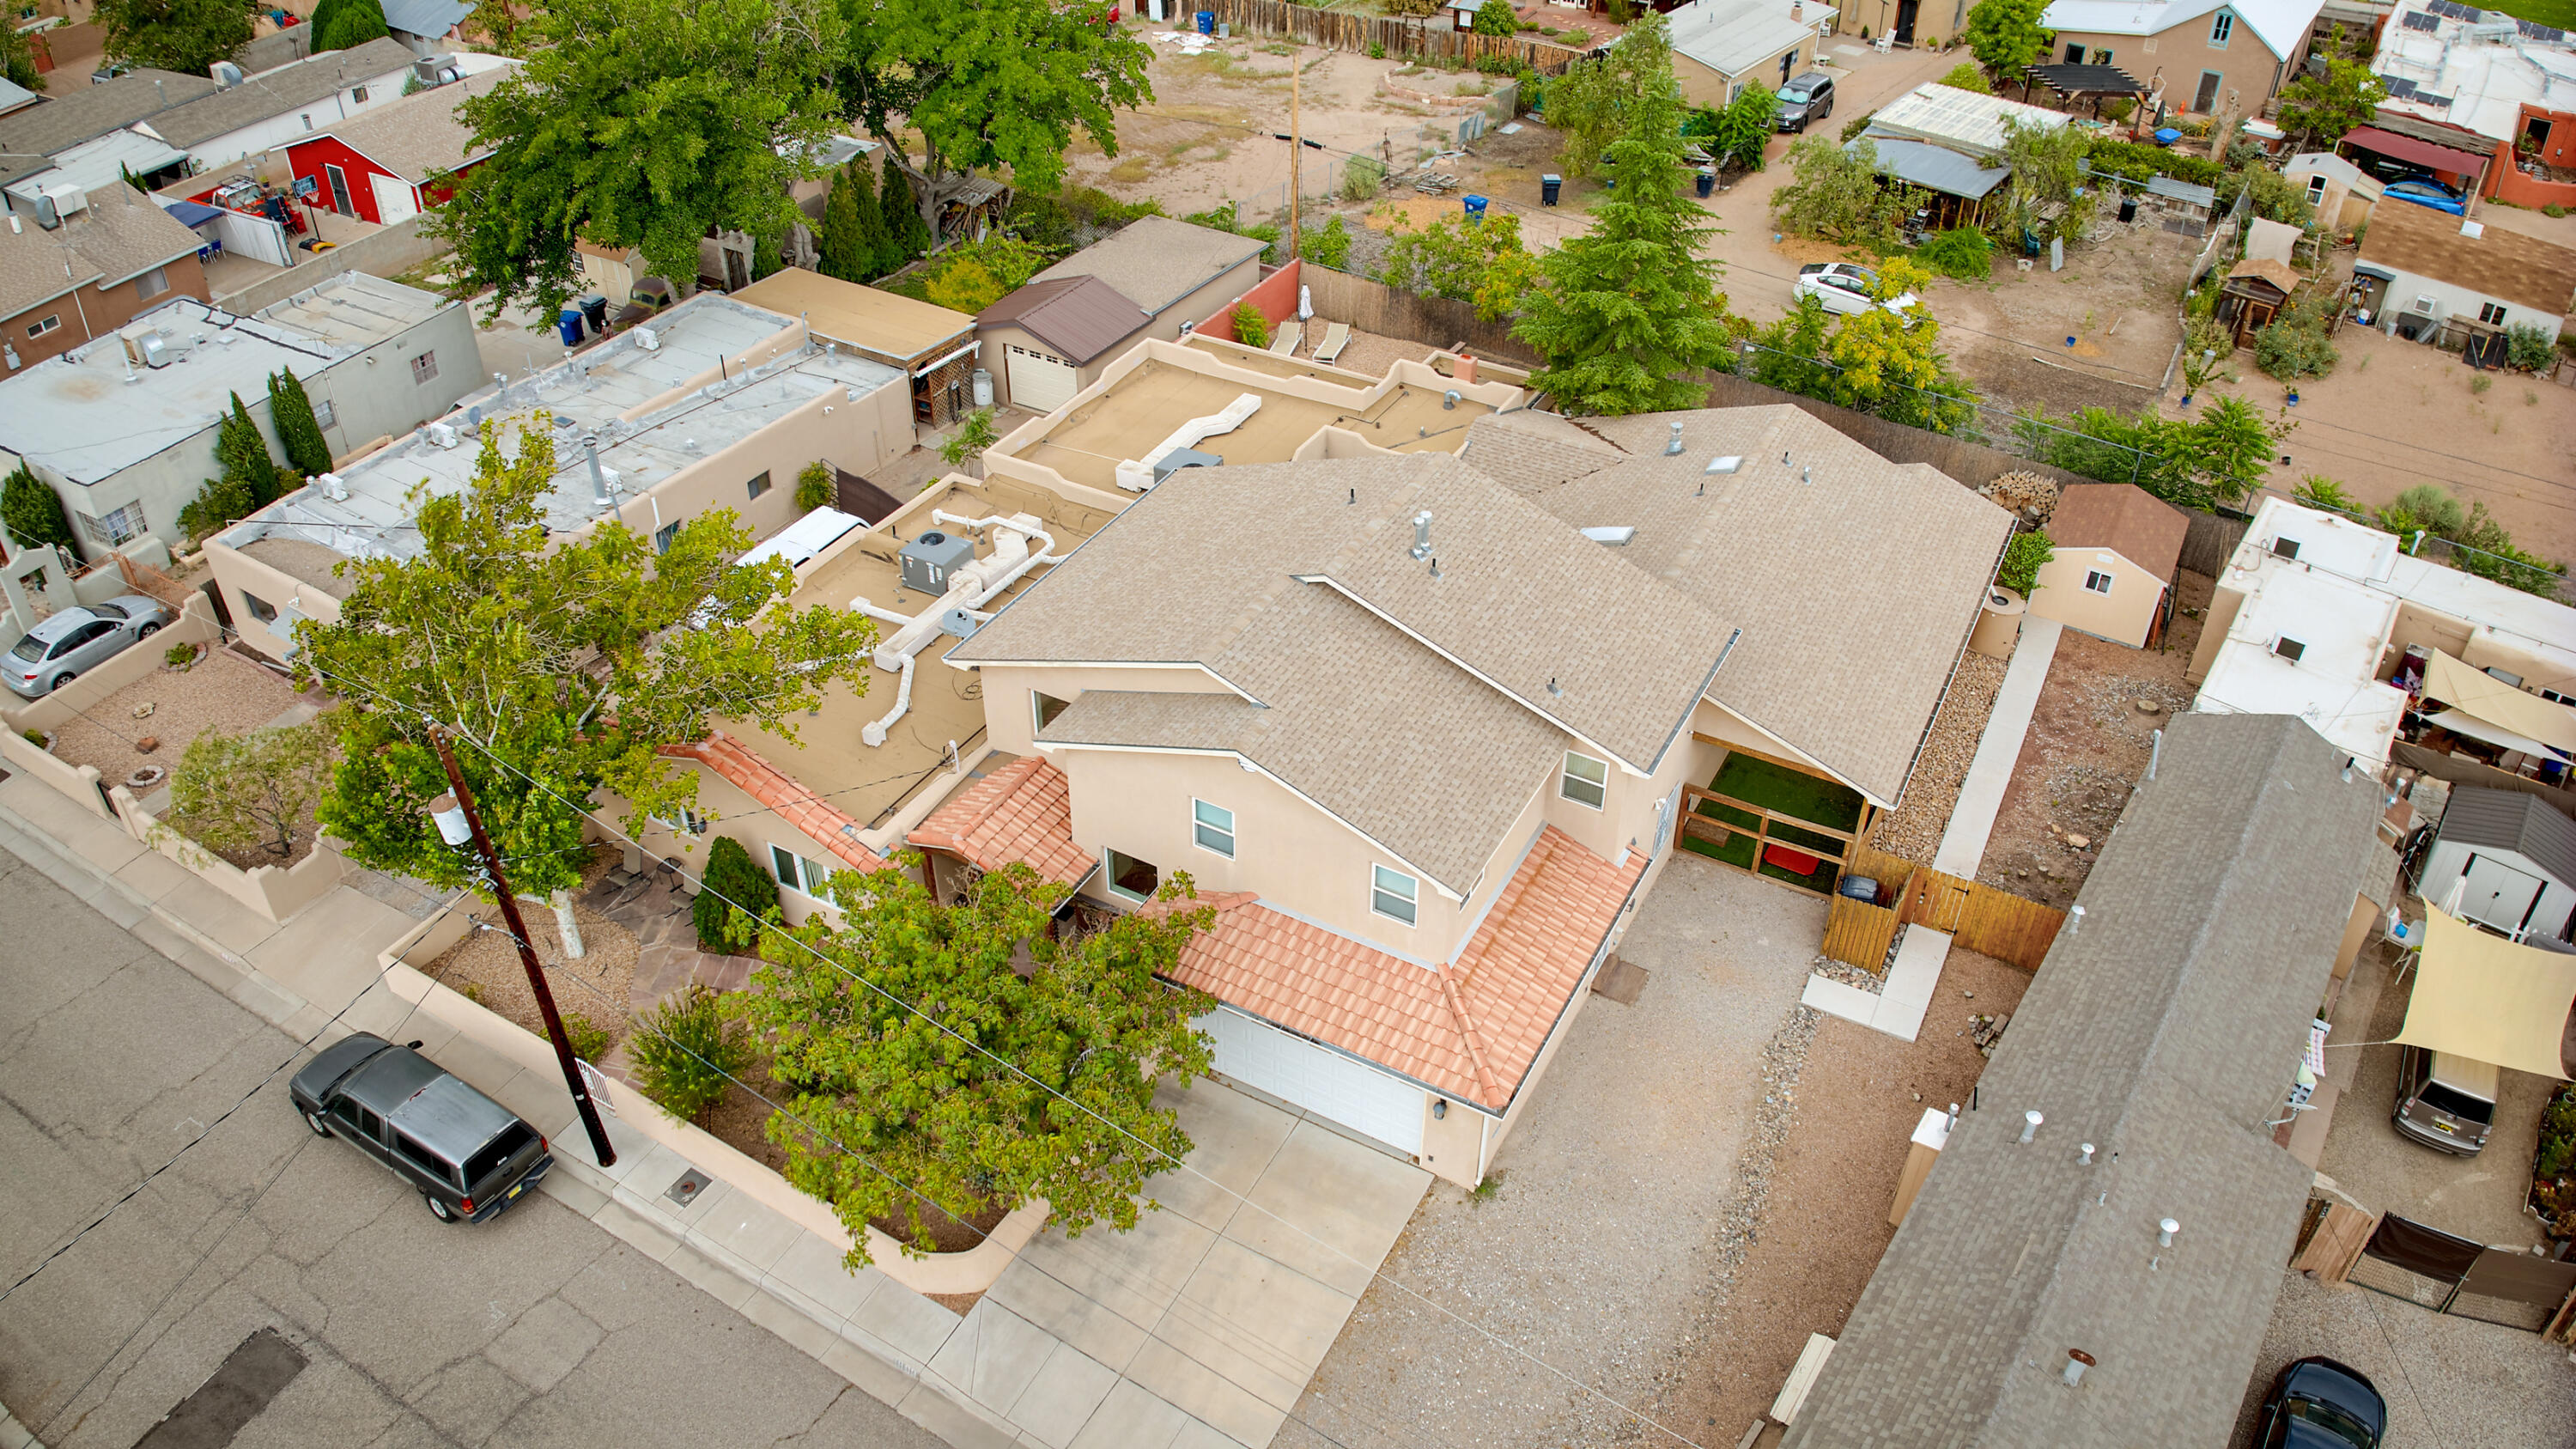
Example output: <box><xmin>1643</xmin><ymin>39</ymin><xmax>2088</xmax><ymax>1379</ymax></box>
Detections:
<box><xmin>1538</xmin><ymin>405</ymin><xmax>2012</xmax><ymax>807</ymax></box>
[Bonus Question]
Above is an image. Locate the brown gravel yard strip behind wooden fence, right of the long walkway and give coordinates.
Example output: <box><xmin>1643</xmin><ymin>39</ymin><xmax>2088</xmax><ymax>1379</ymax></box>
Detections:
<box><xmin>1976</xmin><ymin>572</ymin><xmax>2213</xmax><ymax>908</ymax></box>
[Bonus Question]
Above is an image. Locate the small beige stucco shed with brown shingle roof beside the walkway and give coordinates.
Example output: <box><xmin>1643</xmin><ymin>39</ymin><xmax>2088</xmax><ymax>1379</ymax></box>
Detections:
<box><xmin>2030</xmin><ymin>482</ymin><xmax>2190</xmax><ymax>649</ymax></box>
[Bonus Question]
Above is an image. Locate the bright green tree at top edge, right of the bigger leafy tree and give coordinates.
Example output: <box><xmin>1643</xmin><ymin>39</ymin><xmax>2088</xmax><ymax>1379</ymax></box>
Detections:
<box><xmin>835</xmin><ymin>0</ymin><xmax>1154</xmax><ymax>255</ymax></box>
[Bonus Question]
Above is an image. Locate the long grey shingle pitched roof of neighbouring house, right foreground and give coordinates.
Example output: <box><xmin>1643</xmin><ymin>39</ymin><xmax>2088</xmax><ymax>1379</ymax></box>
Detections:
<box><xmin>1783</xmin><ymin>714</ymin><xmax>2388</xmax><ymax>1449</ymax></box>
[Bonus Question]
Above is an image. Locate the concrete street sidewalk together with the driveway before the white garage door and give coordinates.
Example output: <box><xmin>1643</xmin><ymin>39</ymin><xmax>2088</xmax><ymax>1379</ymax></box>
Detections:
<box><xmin>0</xmin><ymin>776</ymin><xmax>1430</xmax><ymax>1449</ymax></box>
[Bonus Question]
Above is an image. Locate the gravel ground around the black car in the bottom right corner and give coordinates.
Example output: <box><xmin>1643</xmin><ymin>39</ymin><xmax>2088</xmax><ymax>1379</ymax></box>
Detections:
<box><xmin>2231</xmin><ymin>1271</ymin><xmax>2576</xmax><ymax>1449</ymax></box>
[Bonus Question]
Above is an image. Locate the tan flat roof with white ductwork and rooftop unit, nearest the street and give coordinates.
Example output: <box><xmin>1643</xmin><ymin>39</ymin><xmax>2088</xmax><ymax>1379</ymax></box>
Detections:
<box><xmin>716</xmin><ymin>474</ymin><xmax>1115</xmax><ymax>825</ymax></box>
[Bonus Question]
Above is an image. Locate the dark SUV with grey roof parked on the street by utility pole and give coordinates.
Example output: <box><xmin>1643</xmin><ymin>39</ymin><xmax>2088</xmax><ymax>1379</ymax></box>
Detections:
<box><xmin>289</xmin><ymin>1032</ymin><xmax>554</xmax><ymax>1222</ymax></box>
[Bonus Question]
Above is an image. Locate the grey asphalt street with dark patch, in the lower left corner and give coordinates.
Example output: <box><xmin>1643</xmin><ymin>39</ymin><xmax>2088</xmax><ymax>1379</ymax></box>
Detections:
<box><xmin>0</xmin><ymin>851</ymin><xmax>938</xmax><ymax>1449</ymax></box>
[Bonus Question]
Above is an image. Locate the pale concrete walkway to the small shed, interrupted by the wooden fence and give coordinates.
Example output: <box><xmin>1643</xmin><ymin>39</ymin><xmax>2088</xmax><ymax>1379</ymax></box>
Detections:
<box><xmin>1801</xmin><ymin>616</ymin><xmax>2066</xmax><ymax>1042</ymax></box>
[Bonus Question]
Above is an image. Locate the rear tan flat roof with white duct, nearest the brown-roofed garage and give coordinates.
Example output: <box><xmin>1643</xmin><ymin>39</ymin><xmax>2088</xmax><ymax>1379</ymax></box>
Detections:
<box><xmin>1010</xmin><ymin>356</ymin><xmax>1494</xmax><ymax>492</ymax></box>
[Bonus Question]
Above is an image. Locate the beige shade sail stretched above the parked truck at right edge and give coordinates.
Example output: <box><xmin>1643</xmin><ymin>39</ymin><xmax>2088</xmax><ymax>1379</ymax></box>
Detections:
<box><xmin>2396</xmin><ymin>910</ymin><xmax>2576</xmax><ymax>1078</ymax></box>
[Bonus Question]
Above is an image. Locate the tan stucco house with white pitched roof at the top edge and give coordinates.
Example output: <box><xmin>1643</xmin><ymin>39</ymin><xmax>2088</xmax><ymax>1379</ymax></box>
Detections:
<box><xmin>2040</xmin><ymin>0</ymin><xmax>2324</xmax><ymax>116</ymax></box>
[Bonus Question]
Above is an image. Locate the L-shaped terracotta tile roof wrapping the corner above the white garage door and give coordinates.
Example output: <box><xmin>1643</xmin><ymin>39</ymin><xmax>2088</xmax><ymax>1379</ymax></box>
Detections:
<box><xmin>1149</xmin><ymin>825</ymin><xmax>1646</xmax><ymax>1111</ymax></box>
